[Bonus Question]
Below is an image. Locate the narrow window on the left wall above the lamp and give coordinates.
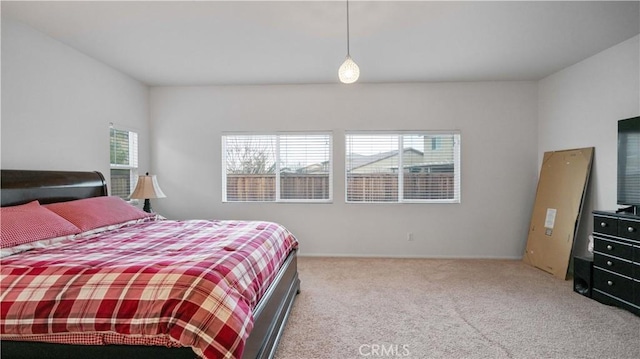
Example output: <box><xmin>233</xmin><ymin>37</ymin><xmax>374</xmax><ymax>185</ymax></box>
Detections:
<box><xmin>109</xmin><ymin>126</ymin><xmax>138</xmax><ymax>200</ymax></box>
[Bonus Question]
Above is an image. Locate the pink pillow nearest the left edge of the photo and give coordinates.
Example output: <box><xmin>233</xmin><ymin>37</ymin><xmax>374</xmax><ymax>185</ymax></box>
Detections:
<box><xmin>0</xmin><ymin>201</ymin><xmax>80</xmax><ymax>248</ymax></box>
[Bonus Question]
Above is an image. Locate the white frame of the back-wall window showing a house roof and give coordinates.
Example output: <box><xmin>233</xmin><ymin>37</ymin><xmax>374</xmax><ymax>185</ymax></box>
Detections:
<box><xmin>344</xmin><ymin>130</ymin><xmax>462</xmax><ymax>204</ymax></box>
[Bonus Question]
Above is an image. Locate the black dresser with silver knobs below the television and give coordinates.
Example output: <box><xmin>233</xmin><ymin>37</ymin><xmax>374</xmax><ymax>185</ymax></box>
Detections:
<box><xmin>592</xmin><ymin>211</ymin><xmax>640</xmax><ymax>315</ymax></box>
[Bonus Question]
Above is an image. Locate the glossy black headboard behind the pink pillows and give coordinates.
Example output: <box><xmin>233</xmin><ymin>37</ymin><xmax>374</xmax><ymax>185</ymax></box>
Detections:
<box><xmin>0</xmin><ymin>170</ymin><xmax>107</xmax><ymax>207</ymax></box>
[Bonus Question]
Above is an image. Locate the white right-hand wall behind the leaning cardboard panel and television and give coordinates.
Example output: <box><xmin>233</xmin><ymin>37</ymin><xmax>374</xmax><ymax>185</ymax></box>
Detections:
<box><xmin>538</xmin><ymin>35</ymin><xmax>640</xmax><ymax>254</ymax></box>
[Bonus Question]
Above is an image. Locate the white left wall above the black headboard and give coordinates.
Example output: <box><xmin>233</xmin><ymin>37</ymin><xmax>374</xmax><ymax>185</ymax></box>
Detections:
<box><xmin>2</xmin><ymin>18</ymin><xmax>149</xmax><ymax>188</ymax></box>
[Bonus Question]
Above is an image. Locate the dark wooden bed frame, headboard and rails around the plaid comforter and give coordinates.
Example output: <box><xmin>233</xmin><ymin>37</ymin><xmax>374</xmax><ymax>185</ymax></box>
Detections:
<box><xmin>0</xmin><ymin>170</ymin><xmax>300</xmax><ymax>359</ymax></box>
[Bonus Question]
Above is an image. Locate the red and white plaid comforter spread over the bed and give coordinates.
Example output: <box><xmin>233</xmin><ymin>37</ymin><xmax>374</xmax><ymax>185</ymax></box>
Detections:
<box><xmin>0</xmin><ymin>220</ymin><xmax>297</xmax><ymax>358</ymax></box>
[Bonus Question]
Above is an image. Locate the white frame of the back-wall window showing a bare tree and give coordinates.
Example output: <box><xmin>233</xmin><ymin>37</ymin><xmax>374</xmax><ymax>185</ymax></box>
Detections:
<box><xmin>220</xmin><ymin>131</ymin><xmax>334</xmax><ymax>204</ymax></box>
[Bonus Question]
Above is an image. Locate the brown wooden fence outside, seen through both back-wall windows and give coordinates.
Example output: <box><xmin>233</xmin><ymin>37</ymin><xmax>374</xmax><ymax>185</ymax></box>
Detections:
<box><xmin>227</xmin><ymin>173</ymin><xmax>454</xmax><ymax>202</ymax></box>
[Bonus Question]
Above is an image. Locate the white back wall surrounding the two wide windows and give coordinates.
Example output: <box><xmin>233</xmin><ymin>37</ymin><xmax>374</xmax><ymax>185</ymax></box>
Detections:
<box><xmin>150</xmin><ymin>82</ymin><xmax>538</xmax><ymax>258</ymax></box>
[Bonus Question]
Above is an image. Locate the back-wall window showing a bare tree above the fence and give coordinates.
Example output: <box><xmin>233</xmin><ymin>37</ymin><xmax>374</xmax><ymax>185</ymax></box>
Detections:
<box><xmin>222</xmin><ymin>133</ymin><xmax>332</xmax><ymax>202</ymax></box>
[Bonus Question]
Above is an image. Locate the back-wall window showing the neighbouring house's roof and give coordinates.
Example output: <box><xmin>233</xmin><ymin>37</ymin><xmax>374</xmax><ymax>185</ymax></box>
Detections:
<box><xmin>345</xmin><ymin>132</ymin><xmax>460</xmax><ymax>203</ymax></box>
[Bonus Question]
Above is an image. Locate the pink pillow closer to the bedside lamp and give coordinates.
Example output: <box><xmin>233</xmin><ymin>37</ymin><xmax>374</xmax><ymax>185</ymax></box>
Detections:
<box><xmin>44</xmin><ymin>196</ymin><xmax>153</xmax><ymax>232</ymax></box>
